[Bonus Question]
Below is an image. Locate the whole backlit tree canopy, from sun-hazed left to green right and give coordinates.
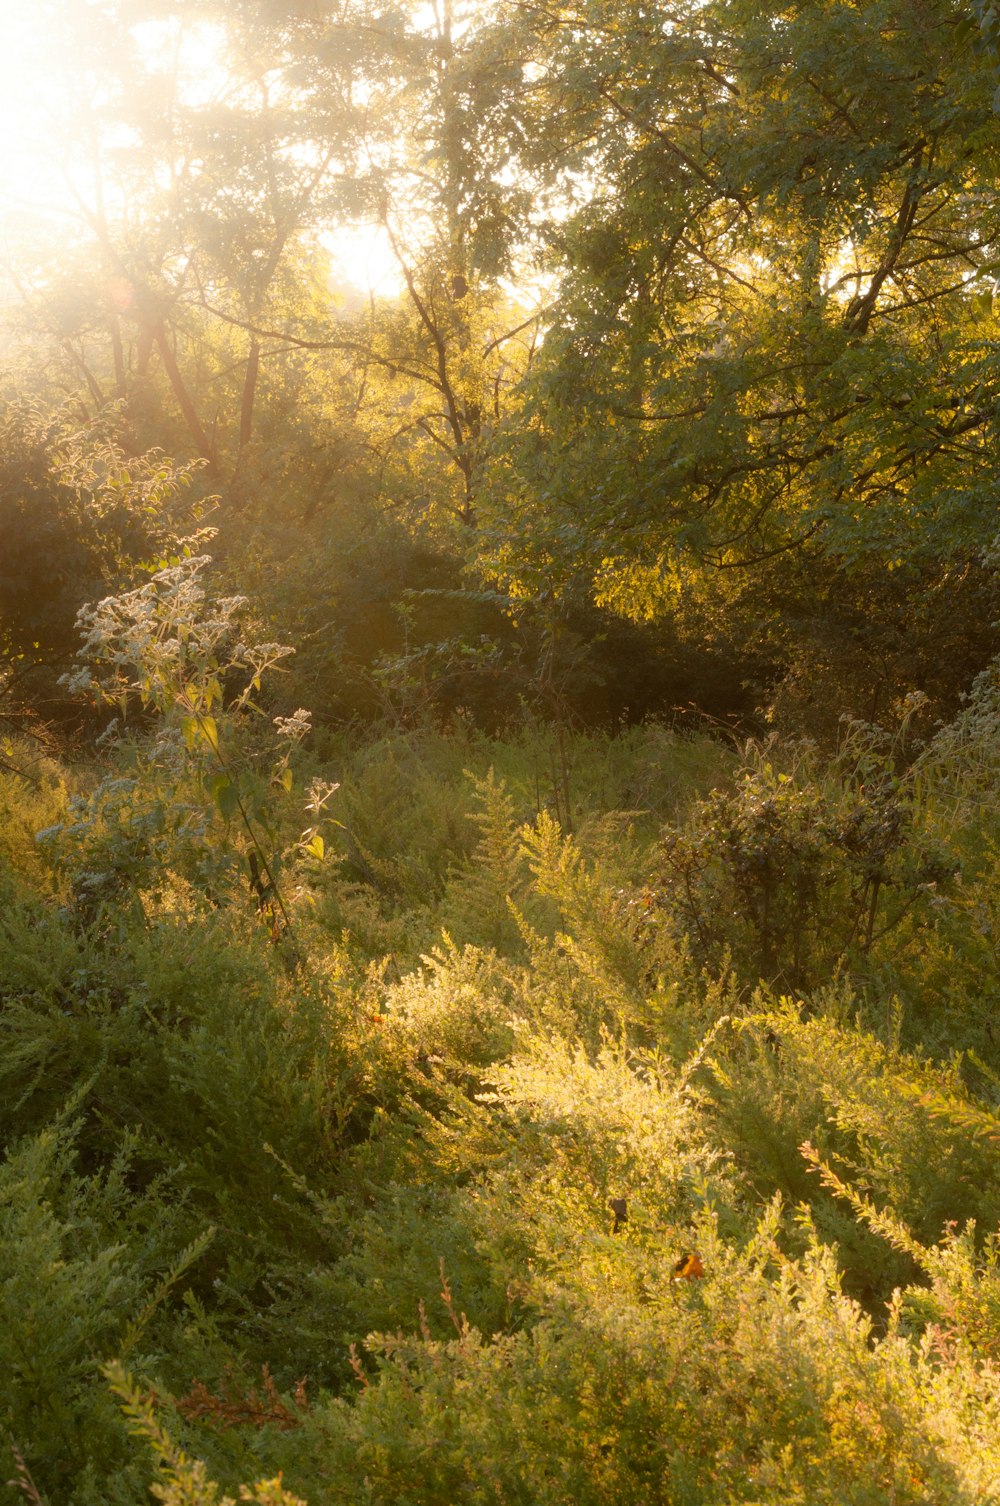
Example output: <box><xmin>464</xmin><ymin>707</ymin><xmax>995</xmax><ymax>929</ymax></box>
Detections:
<box><xmin>1</xmin><ymin>0</ymin><xmax>1000</xmax><ymax>722</ymax></box>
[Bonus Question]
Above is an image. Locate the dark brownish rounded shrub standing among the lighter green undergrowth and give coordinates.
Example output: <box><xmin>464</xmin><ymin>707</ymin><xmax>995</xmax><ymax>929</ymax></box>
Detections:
<box><xmin>661</xmin><ymin>729</ymin><xmax>956</xmax><ymax>991</ymax></box>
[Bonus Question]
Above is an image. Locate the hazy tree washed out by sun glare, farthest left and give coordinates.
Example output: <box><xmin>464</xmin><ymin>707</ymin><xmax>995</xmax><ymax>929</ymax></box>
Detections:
<box><xmin>10</xmin><ymin>0</ymin><xmax>379</xmax><ymax>483</ymax></box>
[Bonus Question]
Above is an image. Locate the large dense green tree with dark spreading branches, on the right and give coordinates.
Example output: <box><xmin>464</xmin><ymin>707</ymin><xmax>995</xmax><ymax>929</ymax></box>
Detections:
<box><xmin>475</xmin><ymin>0</ymin><xmax>1000</xmax><ymax>716</ymax></box>
